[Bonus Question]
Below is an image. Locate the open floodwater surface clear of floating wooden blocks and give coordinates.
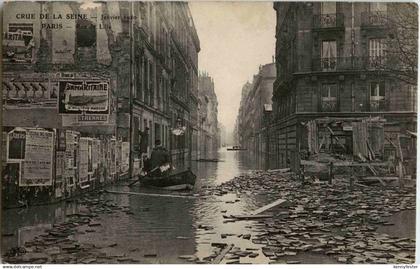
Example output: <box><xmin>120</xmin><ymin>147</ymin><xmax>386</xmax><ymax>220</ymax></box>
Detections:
<box><xmin>2</xmin><ymin>149</ymin><xmax>415</xmax><ymax>263</ymax></box>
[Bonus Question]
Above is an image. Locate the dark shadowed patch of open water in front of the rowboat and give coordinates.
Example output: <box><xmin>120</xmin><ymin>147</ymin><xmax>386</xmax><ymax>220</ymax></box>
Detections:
<box><xmin>77</xmin><ymin>186</ymin><xmax>195</xmax><ymax>263</ymax></box>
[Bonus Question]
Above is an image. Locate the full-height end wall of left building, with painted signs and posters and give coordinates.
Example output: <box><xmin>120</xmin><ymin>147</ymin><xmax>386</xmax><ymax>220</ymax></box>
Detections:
<box><xmin>2</xmin><ymin>2</ymin><xmax>129</xmax><ymax>206</ymax></box>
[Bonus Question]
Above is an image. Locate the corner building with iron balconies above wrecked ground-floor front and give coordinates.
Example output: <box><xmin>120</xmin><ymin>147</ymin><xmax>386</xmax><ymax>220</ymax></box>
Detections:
<box><xmin>269</xmin><ymin>2</ymin><xmax>417</xmax><ymax>172</ymax></box>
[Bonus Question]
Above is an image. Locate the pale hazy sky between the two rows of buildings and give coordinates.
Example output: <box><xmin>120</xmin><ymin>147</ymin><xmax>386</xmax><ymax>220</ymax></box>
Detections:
<box><xmin>189</xmin><ymin>1</ymin><xmax>276</xmax><ymax>132</ymax></box>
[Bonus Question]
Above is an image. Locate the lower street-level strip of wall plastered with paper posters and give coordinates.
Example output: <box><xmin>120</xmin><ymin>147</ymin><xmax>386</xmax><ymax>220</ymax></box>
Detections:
<box><xmin>2</xmin><ymin>127</ymin><xmax>121</xmax><ymax>207</ymax></box>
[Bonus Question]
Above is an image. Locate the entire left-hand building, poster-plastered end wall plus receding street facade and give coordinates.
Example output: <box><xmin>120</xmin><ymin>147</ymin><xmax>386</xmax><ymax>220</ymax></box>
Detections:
<box><xmin>2</xmin><ymin>2</ymin><xmax>200</xmax><ymax>207</ymax></box>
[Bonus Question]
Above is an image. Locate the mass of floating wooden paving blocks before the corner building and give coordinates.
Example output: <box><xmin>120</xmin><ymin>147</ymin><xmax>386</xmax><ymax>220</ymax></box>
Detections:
<box><xmin>205</xmin><ymin>171</ymin><xmax>415</xmax><ymax>263</ymax></box>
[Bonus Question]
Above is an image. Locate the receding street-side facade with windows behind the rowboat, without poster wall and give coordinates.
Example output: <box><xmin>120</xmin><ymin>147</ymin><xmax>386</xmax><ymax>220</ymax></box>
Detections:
<box><xmin>119</xmin><ymin>2</ymin><xmax>200</xmax><ymax>175</ymax></box>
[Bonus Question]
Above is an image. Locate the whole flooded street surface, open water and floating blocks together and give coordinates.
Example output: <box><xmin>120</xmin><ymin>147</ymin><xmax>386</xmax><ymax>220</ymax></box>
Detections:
<box><xmin>2</xmin><ymin>148</ymin><xmax>415</xmax><ymax>263</ymax></box>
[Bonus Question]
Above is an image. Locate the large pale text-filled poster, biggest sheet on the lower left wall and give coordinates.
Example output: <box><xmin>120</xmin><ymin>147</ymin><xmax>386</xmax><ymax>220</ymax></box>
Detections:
<box><xmin>19</xmin><ymin>130</ymin><xmax>54</xmax><ymax>186</ymax></box>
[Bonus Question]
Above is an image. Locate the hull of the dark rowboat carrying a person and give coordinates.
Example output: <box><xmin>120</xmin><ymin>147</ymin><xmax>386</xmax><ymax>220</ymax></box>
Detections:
<box><xmin>140</xmin><ymin>170</ymin><xmax>197</xmax><ymax>190</ymax></box>
